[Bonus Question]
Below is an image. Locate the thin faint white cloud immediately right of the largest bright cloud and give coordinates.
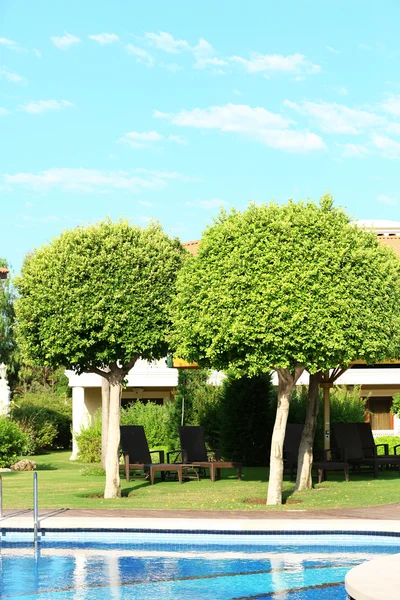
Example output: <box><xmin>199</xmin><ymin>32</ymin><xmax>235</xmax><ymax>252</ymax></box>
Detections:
<box><xmin>284</xmin><ymin>100</ymin><xmax>386</xmax><ymax>134</ymax></box>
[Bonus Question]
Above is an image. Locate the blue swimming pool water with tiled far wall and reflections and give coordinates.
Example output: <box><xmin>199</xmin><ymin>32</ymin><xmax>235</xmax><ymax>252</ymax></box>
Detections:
<box><xmin>0</xmin><ymin>533</ymin><xmax>400</xmax><ymax>600</ymax></box>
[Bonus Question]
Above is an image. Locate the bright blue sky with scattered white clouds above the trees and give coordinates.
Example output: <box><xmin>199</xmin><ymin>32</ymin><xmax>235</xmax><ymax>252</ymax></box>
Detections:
<box><xmin>0</xmin><ymin>0</ymin><xmax>400</xmax><ymax>271</ymax></box>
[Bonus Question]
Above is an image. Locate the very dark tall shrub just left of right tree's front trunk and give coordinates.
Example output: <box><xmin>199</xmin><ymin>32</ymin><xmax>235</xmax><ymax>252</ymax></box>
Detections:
<box><xmin>221</xmin><ymin>375</ymin><xmax>274</xmax><ymax>465</ymax></box>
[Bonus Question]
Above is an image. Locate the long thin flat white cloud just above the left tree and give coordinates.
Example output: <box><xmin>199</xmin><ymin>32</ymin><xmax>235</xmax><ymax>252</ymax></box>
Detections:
<box><xmin>3</xmin><ymin>168</ymin><xmax>192</xmax><ymax>193</ymax></box>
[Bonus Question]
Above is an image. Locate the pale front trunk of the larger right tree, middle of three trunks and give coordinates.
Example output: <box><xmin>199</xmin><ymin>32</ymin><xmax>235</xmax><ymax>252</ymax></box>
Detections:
<box><xmin>267</xmin><ymin>367</ymin><xmax>304</xmax><ymax>505</ymax></box>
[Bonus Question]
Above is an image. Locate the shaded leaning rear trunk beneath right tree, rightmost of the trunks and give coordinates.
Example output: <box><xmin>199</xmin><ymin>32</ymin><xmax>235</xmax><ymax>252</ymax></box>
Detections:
<box><xmin>296</xmin><ymin>373</ymin><xmax>321</xmax><ymax>491</ymax></box>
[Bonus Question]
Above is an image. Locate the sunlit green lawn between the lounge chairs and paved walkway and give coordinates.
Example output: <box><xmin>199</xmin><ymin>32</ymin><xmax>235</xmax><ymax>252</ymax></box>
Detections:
<box><xmin>3</xmin><ymin>452</ymin><xmax>400</xmax><ymax>511</ymax></box>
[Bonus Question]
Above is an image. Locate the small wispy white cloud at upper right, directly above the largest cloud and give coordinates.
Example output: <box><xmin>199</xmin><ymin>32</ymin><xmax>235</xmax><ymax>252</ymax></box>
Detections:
<box><xmin>230</xmin><ymin>52</ymin><xmax>321</xmax><ymax>75</ymax></box>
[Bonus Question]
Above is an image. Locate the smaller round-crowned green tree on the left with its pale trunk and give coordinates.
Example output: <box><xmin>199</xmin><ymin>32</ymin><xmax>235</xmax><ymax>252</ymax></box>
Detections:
<box><xmin>17</xmin><ymin>220</ymin><xmax>186</xmax><ymax>498</ymax></box>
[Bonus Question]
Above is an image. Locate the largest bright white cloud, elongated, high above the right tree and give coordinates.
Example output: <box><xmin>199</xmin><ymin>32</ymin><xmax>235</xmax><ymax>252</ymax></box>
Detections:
<box><xmin>154</xmin><ymin>104</ymin><xmax>325</xmax><ymax>153</ymax></box>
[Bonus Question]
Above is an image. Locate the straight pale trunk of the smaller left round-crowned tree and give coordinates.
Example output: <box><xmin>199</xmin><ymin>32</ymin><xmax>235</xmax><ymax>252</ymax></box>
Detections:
<box><xmin>104</xmin><ymin>376</ymin><xmax>123</xmax><ymax>498</ymax></box>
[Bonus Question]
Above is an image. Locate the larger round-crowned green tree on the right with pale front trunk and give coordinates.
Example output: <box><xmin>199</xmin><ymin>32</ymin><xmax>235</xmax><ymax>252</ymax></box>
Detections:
<box><xmin>173</xmin><ymin>195</ymin><xmax>400</xmax><ymax>504</ymax></box>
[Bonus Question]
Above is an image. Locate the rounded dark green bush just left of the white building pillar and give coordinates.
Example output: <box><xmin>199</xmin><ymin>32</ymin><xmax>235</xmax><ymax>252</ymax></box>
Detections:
<box><xmin>11</xmin><ymin>392</ymin><xmax>72</xmax><ymax>453</ymax></box>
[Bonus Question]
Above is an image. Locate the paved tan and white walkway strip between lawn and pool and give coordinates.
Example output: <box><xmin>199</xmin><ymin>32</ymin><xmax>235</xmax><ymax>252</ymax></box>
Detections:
<box><xmin>0</xmin><ymin>504</ymin><xmax>400</xmax><ymax>534</ymax></box>
